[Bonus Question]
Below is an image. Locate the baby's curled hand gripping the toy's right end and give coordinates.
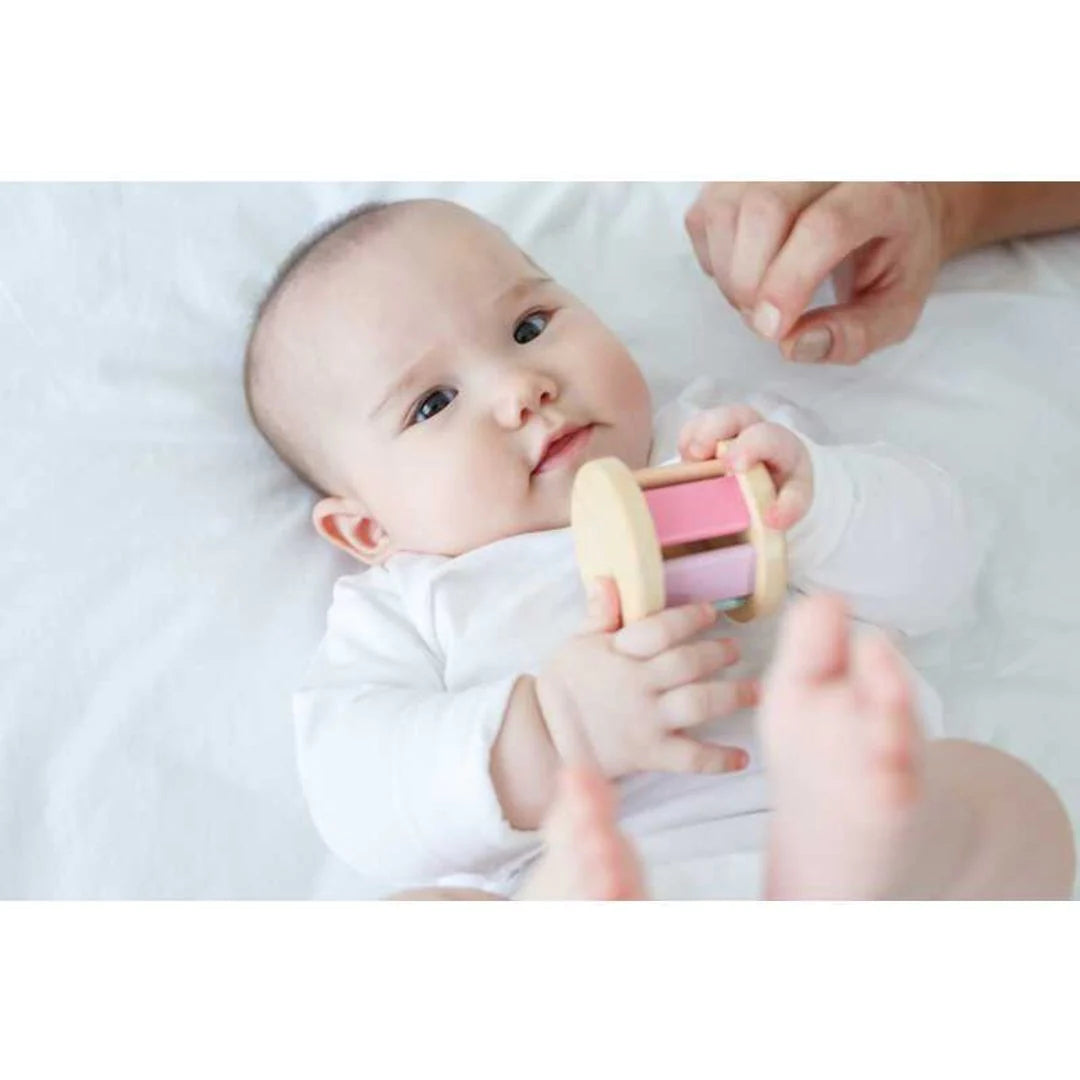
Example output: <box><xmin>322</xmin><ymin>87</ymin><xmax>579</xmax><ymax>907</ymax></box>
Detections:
<box><xmin>678</xmin><ymin>405</ymin><xmax>813</xmax><ymax>529</ymax></box>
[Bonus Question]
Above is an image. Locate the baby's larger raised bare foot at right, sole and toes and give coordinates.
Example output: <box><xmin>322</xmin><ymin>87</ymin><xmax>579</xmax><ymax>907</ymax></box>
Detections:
<box><xmin>760</xmin><ymin>596</ymin><xmax>923</xmax><ymax>900</ymax></box>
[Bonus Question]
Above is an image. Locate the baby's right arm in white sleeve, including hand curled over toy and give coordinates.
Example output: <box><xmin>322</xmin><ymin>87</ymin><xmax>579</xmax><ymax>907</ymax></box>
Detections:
<box><xmin>680</xmin><ymin>386</ymin><xmax>976</xmax><ymax>634</ymax></box>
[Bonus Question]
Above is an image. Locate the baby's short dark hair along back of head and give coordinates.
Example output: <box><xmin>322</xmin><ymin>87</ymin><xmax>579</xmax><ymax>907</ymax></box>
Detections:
<box><xmin>244</xmin><ymin>202</ymin><xmax>402</xmax><ymax>495</ymax></box>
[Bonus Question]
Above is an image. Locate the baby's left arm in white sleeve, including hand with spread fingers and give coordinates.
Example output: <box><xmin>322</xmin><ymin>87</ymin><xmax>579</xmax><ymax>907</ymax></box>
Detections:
<box><xmin>294</xmin><ymin>579</ymin><xmax>756</xmax><ymax>887</ymax></box>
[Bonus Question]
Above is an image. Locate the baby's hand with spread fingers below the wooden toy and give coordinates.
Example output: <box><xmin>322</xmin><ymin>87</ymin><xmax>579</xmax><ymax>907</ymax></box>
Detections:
<box><xmin>536</xmin><ymin>580</ymin><xmax>757</xmax><ymax>778</ymax></box>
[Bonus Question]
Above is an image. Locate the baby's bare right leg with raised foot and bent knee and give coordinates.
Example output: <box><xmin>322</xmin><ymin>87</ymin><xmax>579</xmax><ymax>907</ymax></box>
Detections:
<box><xmin>760</xmin><ymin>596</ymin><xmax>1075</xmax><ymax>899</ymax></box>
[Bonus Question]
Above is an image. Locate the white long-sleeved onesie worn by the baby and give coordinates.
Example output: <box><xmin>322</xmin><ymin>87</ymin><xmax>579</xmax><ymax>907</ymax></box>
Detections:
<box><xmin>294</xmin><ymin>379</ymin><xmax>974</xmax><ymax>899</ymax></box>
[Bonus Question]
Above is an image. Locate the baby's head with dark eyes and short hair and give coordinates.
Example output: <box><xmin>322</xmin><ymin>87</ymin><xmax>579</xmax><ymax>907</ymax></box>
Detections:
<box><xmin>245</xmin><ymin>200</ymin><xmax>651</xmax><ymax>563</ymax></box>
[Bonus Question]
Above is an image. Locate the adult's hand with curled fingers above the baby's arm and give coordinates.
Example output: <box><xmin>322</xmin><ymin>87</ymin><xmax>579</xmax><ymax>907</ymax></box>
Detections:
<box><xmin>686</xmin><ymin>184</ymin><xmax>947</xmax><ymax>364</ymax></box>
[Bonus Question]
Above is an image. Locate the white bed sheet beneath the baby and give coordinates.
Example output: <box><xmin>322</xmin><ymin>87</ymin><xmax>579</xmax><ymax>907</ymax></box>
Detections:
<box><xmin>0</xmin><ymin>184</ymin><xmax>1080</xmax><ymax>899</ymax></box>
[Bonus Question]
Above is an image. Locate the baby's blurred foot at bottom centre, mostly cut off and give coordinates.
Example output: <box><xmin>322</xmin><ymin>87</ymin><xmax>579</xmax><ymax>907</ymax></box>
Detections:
<box><xmin>515</xmin><ymin>769</ymin><xmax>645</xmax><ymax>900</ymax></box>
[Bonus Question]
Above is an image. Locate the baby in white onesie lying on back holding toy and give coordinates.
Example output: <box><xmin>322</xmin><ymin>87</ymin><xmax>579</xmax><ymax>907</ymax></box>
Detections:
<box><xmin>245</xmin><ymin>200</ymin><xmax>1072</xmax><ymax>899</ymax></box>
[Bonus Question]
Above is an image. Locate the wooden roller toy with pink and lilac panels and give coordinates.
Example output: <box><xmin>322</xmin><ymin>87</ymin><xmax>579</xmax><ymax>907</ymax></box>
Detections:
<box><xmin>570</xmin><ymin>444</ymin><xmax>787</xmax><ymax>622</ymax></box>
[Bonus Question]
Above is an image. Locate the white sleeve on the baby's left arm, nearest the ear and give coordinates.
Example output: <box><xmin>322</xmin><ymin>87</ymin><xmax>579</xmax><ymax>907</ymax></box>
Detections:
<box><xmin>294</xmin><ymin>575</ymin><xmax>537</xmax><ymax>887</ymax></box>
